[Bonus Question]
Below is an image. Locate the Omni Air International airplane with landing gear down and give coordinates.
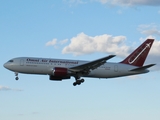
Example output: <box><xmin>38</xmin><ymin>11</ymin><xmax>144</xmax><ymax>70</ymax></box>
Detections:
<box><xmin>3</xmin><ymin>39</ymin><xmax>155</xmax><ymax>86</ymax></box>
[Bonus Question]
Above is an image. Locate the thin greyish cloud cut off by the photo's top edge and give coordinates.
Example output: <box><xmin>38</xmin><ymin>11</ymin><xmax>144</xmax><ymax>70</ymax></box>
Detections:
<box><xmin>95</xmin><ymin>0</ymin><xmax>160</xmax><ymax>6</ymax></box>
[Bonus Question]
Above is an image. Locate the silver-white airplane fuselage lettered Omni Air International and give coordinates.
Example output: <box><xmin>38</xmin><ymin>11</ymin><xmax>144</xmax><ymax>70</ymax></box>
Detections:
<box><xmin>4</xmin><ymin>57</ymin><xmax>149</xmax><ymax>78</ymax></box>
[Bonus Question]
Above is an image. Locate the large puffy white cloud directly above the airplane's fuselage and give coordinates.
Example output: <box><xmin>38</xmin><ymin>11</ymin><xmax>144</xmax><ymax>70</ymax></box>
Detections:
<box><xmin>62</xmin><ymin>33</ymin><xmax>130</xmax><ymax>57</ymax></box>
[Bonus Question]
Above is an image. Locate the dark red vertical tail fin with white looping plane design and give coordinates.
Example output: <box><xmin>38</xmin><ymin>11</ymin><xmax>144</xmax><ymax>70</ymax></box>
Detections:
<box><xmin>120</xmin><ymin>39</ymin><xmax>154</xmax><ymax>67</ymax></box>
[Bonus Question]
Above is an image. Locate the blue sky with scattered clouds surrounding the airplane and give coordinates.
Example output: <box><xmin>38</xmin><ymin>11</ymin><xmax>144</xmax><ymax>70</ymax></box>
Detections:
<box><xmin>0</xmin><ymin>0</ymin><xmax>160</xmax><ymax>120</ymax></box>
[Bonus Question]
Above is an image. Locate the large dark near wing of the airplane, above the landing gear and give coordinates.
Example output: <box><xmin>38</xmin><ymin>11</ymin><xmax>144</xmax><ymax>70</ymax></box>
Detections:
<box><xmin>69</xmin><ymin>55</ymin><xmax>116</xmax><ymax>72</ymax></box>
